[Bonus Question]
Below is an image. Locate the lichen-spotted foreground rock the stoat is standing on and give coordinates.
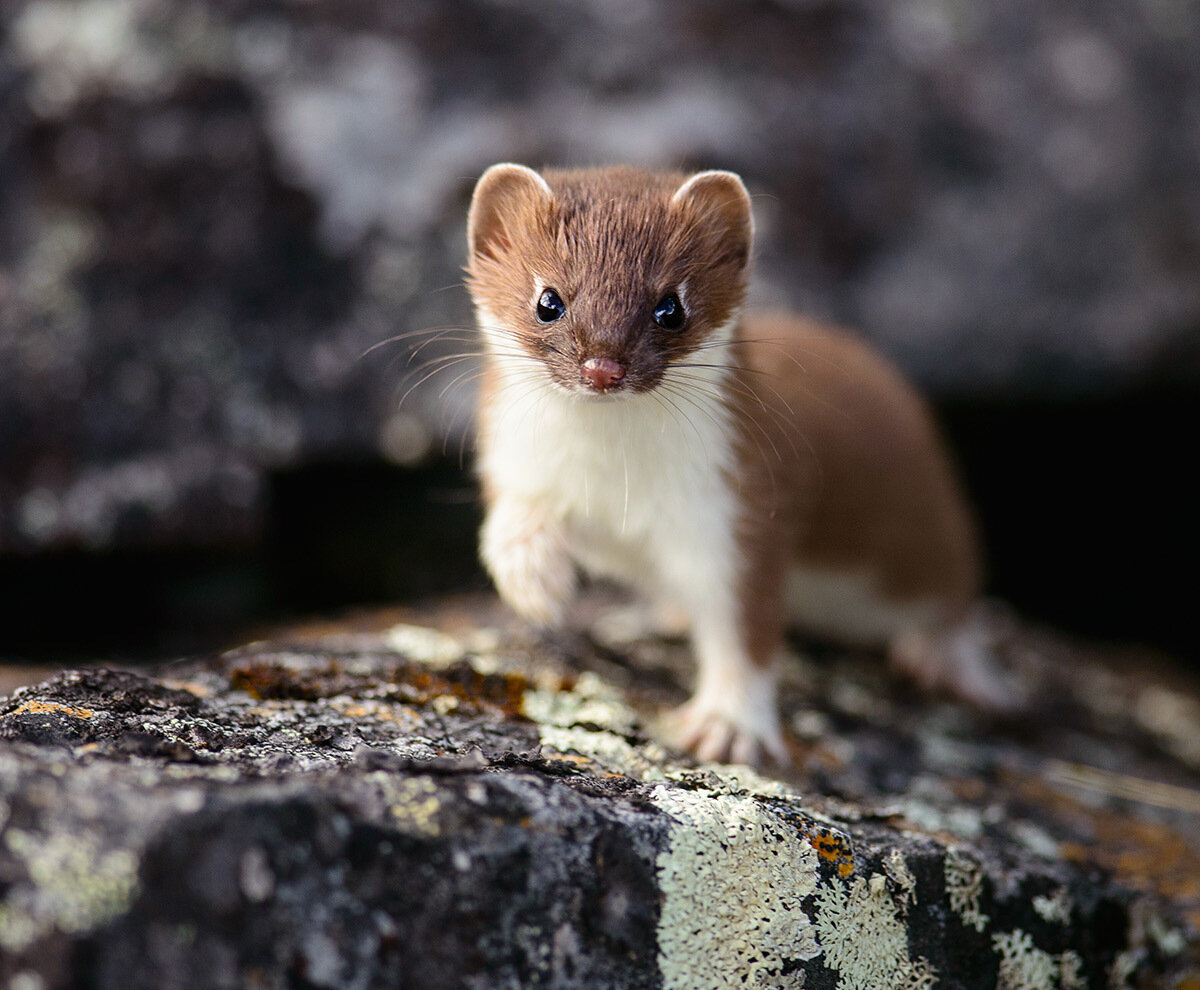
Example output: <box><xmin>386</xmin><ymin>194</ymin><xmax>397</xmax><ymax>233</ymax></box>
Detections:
<box><xmin>0</xmin><ymin>598</ymin><xmax>1200</xmax><ymax>990</ymax></box>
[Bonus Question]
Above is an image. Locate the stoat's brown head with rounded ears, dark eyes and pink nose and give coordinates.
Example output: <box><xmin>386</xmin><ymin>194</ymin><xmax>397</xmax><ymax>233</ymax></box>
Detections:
<box><xmin>467</xmin><ymin>164</ymin><xmax>754</xmax><ymax>395</ymax></box>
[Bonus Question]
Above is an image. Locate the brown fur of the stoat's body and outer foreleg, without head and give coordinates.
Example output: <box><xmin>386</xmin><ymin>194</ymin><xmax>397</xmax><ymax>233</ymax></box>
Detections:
<box><xmin>732</xmin><ymin>313</ymin><xmax>982</xmax><ymax>664</ymax></box>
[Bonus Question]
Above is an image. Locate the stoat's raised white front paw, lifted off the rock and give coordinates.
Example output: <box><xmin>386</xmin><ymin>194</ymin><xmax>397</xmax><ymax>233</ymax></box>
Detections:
<box><xmin>480</xmin><ymin>505</ymin><xmax>577</xmax><ymax>626</ymax></box>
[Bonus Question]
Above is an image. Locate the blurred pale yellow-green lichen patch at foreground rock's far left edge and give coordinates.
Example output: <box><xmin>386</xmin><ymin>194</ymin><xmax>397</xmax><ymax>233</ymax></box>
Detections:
<box><xmin>0</xmin><ymin>829</ymin><xmax>137</xmax><ymax>952</ymax></box>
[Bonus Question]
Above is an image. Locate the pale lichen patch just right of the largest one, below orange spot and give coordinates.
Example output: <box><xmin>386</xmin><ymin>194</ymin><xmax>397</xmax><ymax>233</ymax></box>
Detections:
<box><xmin>816</xmin><ymin>874</ymin><xmax>936</xmax><ymax>990</ymax></box>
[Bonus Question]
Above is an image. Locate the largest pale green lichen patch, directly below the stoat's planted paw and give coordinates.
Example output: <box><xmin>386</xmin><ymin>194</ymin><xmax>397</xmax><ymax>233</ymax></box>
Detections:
<box><xmin>654</xmin><ymin>786</ymin><xmax>821</xmax><ymax>990</ymax></box>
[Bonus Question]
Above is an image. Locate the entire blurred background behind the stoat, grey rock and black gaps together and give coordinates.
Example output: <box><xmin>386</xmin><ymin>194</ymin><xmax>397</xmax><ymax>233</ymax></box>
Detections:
<box><xmin>0</xmin><ymin>0</ymin><xmax>1200</xmax><ymax>656</ymax></box>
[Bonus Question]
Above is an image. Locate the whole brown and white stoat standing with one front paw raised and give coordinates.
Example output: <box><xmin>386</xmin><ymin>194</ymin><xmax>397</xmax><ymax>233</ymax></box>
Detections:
<box><xmin>467</xmin><ymin>164</ymin><xmax>995</xmax><ymax>762</ymax></box>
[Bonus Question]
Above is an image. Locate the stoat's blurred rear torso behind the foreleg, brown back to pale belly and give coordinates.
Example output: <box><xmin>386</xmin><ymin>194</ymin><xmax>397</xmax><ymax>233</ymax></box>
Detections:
<box><xmin>724</xmin><ymin>312</ymin><xmax>983</xmax><ymax>644</ymax></box>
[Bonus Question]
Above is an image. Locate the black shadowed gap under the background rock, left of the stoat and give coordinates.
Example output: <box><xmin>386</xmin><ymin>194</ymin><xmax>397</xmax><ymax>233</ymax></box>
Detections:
<box><xmin>0</xmin><ymin>463</ymin><xmax>486</xmax><ymax>665</ymax></box>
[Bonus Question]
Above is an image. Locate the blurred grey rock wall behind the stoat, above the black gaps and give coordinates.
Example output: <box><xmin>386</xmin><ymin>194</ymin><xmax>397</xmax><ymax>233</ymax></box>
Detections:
<box><xmin>0</xmin><ymin>0</ymin><xmax>1200</xmax><ymax>552</ymax></box>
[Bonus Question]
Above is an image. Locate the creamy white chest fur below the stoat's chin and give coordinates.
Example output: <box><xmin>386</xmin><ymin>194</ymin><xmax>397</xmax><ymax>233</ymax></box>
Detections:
<box><xmin>480</xmin><ymin>361</ymin><xmax>737</xmax><ymax>604</ymax></box>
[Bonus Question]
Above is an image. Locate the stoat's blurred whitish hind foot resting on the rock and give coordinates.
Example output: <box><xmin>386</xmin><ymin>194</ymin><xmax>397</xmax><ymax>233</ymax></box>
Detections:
<box><xmin>888</xmin><ymin>606</ymin><xmax>1026</xmax><ymax>714</ymax></box>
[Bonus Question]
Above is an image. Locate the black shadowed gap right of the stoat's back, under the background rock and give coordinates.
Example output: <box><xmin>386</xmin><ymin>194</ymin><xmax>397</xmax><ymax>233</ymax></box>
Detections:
<box><xmin>938</xmin><ymin>389</ymin><xmax>1200</xmax><ymax>662</ymax></box>
